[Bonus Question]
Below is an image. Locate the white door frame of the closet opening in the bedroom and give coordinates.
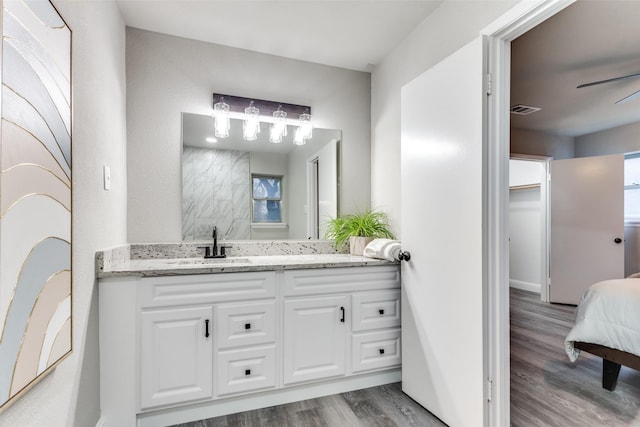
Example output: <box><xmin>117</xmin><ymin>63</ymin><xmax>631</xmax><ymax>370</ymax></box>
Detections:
<box><xmin>509</xmin><ymin>153</ymin><xmax>553</xmax><ymax>302</ymax></box>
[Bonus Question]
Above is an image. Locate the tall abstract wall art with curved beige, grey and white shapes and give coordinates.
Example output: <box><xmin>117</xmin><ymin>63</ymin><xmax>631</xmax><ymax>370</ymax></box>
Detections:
<box><xmin>0</xmin><ymin>0</ymin><xmax>71</xmax><ymax>410</ymax></box>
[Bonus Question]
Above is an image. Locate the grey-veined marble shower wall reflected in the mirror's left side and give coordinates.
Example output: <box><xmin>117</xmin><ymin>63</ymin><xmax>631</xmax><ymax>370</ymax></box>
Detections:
<box><xmin>182</xmin><ymin>146</ymin><xmax>251</xmax><ymax>240</ymax></box>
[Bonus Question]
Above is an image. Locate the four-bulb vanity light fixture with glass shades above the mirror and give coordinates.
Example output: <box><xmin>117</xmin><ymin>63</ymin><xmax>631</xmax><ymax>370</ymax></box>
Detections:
<box><xmin>213</xmin><ymin>93</ymin><xmax>313</xmax><ymax>145</ymax></box>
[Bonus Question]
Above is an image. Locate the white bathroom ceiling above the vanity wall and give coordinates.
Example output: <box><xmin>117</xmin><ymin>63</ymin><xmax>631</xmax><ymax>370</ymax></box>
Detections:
<box><xmin>116</xmin><ymin>0</ymin><xmax>441</xmax><ymax>71</ymax></box>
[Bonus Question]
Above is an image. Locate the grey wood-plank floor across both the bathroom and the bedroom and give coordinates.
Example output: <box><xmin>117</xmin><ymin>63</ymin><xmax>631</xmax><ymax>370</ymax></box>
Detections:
<box><xmin>171</xmin><ymin>290</ymin><xmax>640</xmax><ymax>427</ymax></box>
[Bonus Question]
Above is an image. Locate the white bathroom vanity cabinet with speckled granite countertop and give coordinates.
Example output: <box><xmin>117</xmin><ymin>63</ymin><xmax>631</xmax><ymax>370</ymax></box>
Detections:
<box><xmin>97</xmin><ymin>244</ymin><xmax>401</xmax><ymax>427</ymax></box>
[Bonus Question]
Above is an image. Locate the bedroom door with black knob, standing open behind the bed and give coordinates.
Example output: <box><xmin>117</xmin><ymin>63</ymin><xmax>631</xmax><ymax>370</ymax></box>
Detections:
<box><xmin>549</xmin><ymin>154</ymin><xmax>624</xmax><ymax>304</ymax></box>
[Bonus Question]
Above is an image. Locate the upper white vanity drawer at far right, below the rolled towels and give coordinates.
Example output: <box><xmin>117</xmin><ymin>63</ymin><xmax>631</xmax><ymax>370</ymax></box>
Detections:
<box><xmin>351</xmin><ymin>291</ymin><xmax>400</xmax><ymax>332</ymax></box>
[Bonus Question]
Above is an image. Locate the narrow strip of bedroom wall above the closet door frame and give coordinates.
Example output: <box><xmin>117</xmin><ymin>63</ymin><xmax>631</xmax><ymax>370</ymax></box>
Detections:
<box><xmin>511</xmin><ymin>129</ymin><xmax>575</xmax><ymax>160</ymax></box>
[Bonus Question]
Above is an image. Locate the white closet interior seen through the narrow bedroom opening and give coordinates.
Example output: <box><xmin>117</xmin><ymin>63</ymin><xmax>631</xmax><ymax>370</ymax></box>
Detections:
<box><xmin>509</xmin><ymin>159</ymin><xmax>544</xmax><ymax>292</ymax></box>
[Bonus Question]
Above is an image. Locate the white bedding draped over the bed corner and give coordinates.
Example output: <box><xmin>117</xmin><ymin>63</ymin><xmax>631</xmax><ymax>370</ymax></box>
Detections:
<box><xmin>564</xmin><ymin>279</ymin><xmax>640</xmax><ymax>362</ymax></box>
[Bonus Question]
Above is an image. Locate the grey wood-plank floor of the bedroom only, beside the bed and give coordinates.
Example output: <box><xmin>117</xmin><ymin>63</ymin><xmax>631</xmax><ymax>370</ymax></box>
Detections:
<box><xmin>510</xmin><ymin>289</ymin><xmax>640</xmax><ymax>427</ymax></box>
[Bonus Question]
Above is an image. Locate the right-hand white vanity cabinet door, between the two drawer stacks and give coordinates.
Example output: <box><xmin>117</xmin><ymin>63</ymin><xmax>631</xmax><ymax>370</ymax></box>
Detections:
<box><xmin>284</xmin><ymin>295</ymin><xmax>350</xmax><ymax>384</ymax></box>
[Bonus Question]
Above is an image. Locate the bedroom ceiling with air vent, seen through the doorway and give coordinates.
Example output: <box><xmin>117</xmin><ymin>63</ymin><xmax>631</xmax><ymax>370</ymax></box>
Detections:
<box><xmin>511</xmin><ymin>0</ymin><xmax>640</xmax><ymax>136</ymax></box>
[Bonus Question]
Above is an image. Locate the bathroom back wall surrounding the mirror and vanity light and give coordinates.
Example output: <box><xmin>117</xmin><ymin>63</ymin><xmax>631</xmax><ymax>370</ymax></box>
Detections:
<box><xmin>127</xmin><ymin>28</ymin><xmax>371</xmax><ymax>242</ymax></box>
